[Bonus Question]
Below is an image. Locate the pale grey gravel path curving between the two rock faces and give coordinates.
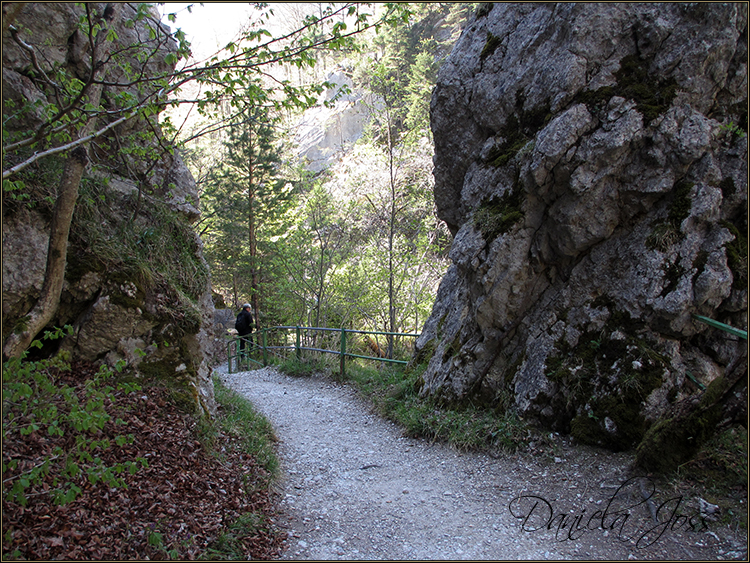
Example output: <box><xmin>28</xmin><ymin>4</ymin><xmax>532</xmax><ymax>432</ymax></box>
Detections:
<box><xmin>217</xmin><ymin>367</ymin><xmax>747</xmax><ymax>560</ymax></box>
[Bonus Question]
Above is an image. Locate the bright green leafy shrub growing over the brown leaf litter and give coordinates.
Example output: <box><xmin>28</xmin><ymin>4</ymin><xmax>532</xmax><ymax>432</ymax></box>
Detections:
<box><xmin>2</xmin><ymin>329</ymin><xmax>147</xmax><ymax>506</ymax></box>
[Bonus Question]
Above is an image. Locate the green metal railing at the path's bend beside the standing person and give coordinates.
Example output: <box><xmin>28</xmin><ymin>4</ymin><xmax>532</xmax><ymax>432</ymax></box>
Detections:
<box><xmin>227</xmin><ymin>326</ymin><xmax>419</xmax><ymax>377</ymax></box>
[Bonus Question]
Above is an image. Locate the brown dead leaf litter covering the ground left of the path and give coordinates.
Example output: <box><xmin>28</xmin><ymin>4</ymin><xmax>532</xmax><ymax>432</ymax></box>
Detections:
<box><xmin>2</xmin><ymin>362</ymin><xmax>281</xmax><ymax>560</ymax></box>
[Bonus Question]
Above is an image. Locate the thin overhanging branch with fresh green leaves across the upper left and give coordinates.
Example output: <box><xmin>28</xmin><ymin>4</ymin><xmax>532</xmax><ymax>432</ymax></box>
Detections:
<box><xmin>3</xmin><ymin>3</ymin><xmax>410</xmax><ymax>179</ymax></box>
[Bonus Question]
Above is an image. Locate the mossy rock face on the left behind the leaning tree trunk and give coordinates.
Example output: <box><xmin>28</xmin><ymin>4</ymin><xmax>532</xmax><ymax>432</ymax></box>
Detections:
<box><xmin>3</xmin><ymin>3</ymin><xmax>215</xmax><ymax>413</ymax></box>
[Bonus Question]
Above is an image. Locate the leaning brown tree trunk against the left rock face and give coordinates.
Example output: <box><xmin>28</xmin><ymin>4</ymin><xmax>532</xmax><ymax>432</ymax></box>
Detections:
<box><xmin>3</xmin><ymin>3</ymin><xmax>122</xmax><ymax>358</ymax></box>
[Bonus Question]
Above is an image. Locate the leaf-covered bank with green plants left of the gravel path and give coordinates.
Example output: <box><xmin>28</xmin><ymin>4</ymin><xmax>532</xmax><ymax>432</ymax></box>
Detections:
<box><xmin>2</xmin><ymin>330</ymin><xmax>280</xmax><ymax>560</ymax></box>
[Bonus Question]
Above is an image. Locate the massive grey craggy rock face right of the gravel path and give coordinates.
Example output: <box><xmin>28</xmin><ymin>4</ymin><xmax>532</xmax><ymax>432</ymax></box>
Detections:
<box><xmin>417</xmin><ymin>3</ymin><xmax>747</xmax><ymax>449</ymax></box>
